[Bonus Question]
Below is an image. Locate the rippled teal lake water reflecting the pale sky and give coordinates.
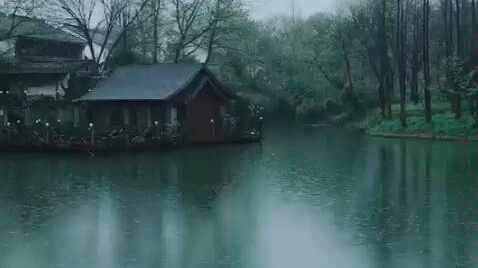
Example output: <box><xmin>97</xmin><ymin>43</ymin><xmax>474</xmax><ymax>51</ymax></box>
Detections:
<box><xmin>0</xmin><ymin>127</ymin><xmax>478</xmax><ymax>268</ymax></box>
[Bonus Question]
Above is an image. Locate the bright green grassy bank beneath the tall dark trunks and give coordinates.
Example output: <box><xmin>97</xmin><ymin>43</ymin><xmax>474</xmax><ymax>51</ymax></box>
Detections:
<box><xmin>366</xmin><ymin>112</ymin><xmax>478</xmax><ymax>140</ymax></box>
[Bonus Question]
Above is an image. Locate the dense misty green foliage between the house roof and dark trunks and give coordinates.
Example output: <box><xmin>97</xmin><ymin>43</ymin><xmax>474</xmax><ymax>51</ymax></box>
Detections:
<box><xmin>207</xmin><ymin>9</ymin><xmax>367</xmax><ymax>116</ymax></box>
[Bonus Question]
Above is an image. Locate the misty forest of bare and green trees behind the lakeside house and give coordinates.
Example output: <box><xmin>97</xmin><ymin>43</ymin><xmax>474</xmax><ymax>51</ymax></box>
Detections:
<box><xmin>0</xmin><ymin>0</ymin><xmax>478</xmax><ymax>121</ymax></box>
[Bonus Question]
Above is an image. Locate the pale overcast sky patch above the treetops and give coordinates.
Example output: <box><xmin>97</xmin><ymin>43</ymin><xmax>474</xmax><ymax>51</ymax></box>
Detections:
<box><xmin>250</xmin><ymin>0</ymin><xmax>353</xmax><ymax>19</ymax></box>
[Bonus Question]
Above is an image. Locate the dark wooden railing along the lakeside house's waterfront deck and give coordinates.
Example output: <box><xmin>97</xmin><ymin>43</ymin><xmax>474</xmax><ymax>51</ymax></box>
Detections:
<box><xmin>0</xmin><ymin>114</ymin><xmax>262</xmax><ymax>149</ymax></box>
